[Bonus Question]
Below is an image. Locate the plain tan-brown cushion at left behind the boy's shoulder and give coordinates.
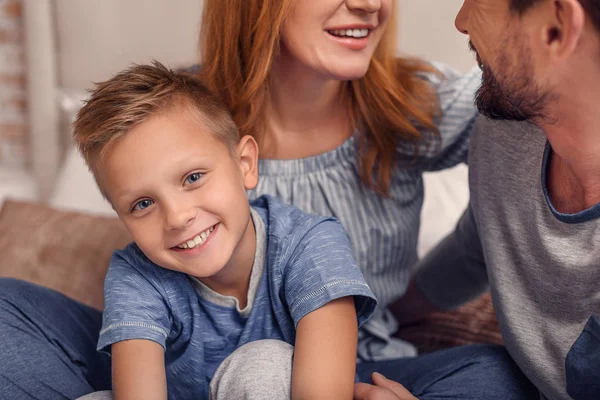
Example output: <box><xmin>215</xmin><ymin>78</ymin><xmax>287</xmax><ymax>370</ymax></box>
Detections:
<box><xmin>0</xmin><ymin>200</ymin><xmax>131</xmax><ymax>309</ymax></box>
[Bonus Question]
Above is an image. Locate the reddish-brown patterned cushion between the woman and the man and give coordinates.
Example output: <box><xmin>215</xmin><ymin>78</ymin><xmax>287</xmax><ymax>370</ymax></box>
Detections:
<box><xmin>396</xmin><ymin>293</ymin><xmax>502</xmax><ymax>353</ymax></box>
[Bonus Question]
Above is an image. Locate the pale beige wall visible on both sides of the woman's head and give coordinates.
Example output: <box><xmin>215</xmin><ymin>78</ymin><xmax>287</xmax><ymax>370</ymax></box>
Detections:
<box><xmin>52</xmin><ymin>0</ymin><xmax>474</xmax><ymax>88</ymax></box>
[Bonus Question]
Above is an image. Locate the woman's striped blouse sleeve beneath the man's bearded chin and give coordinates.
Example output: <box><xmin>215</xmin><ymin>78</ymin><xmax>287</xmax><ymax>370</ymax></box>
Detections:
<box><xmin>426</xmin><ymin>63</ymin><xmax>481</xmax><ymax>171</ymax></box>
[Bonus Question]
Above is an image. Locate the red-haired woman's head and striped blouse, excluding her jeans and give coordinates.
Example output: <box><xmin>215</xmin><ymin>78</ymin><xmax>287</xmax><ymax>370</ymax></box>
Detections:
<box><xmin>200</xmin><ymin>0</ymin><xmax>480</xmax><ymax>360</ymax></box>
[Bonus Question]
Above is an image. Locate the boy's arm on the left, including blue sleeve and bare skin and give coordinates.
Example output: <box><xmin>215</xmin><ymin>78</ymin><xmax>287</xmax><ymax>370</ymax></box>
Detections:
<box><xmin>98</xmin><ymin>250</ymin><xmax>173</xmax><ymax>400</ymax></box>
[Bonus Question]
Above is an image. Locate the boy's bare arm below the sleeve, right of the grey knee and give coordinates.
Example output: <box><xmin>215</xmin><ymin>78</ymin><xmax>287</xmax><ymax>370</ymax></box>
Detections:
<box><xmin>292</xmin><ymin>297</ymin><xmax>358</xmax><ymax>400</ymax></box>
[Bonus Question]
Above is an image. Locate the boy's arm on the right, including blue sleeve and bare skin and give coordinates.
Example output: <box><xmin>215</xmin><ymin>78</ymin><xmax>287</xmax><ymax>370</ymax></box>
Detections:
<box><xmin>281</xmin><ymin>218</ymin><xmax>377</xmax><ymax>400</ymax></box>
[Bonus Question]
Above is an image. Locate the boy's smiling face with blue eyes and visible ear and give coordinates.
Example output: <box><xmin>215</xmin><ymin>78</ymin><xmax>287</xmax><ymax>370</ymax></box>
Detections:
<box><xmin>98</xmin><ymin>108</ymin><xmax>258</xmax><ymax>290</ymax></box>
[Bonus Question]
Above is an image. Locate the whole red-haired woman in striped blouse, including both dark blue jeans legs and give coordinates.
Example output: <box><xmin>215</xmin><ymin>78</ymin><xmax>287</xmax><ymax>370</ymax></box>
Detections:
<box><xmin>0</xmin><ymin>0</ymin><xmax>536</xmax><ymax>399</ymax></box>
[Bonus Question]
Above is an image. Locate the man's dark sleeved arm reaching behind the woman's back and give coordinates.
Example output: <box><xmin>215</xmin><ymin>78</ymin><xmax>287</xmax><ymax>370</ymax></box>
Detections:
<box><xmin>415</xmin><ymin>206</ymin><xmax>488</xmax><ymax>310</ymax></box>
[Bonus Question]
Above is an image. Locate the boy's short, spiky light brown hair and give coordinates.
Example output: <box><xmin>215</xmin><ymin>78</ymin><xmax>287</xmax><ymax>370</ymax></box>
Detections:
<box><xmin>73</xmin><ymin>61</ymin><xmax>239</xmax><ymax>190</ymax></box>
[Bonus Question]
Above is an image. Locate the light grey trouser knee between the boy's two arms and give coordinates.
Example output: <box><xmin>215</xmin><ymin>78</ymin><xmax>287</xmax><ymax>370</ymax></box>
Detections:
<box><xmin>209</xmin><ymin>339</ymin><xmax>294</xmax><ymax>400</ymax></box>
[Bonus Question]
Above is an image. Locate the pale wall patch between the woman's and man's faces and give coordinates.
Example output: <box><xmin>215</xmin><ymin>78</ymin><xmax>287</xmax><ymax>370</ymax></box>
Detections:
<box><xmin>396</xmin><ymin>0</ymin><xmax>475</xmax><ymax>71</ymax></box>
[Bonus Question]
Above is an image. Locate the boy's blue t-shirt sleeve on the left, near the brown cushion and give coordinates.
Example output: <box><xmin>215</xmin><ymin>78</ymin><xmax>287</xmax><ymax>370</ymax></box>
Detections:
<box><xmin>98</xmin><ymin>250</ymin><xmax>171</xmax><ymax>352</ymax></box>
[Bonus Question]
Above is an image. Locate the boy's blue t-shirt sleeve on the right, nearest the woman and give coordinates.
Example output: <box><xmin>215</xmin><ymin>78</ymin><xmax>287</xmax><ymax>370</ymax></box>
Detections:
<box><xmin>283</xmin><ymin>219</ymin><xmax>377</xmax><ymax>326</ymax></box>
